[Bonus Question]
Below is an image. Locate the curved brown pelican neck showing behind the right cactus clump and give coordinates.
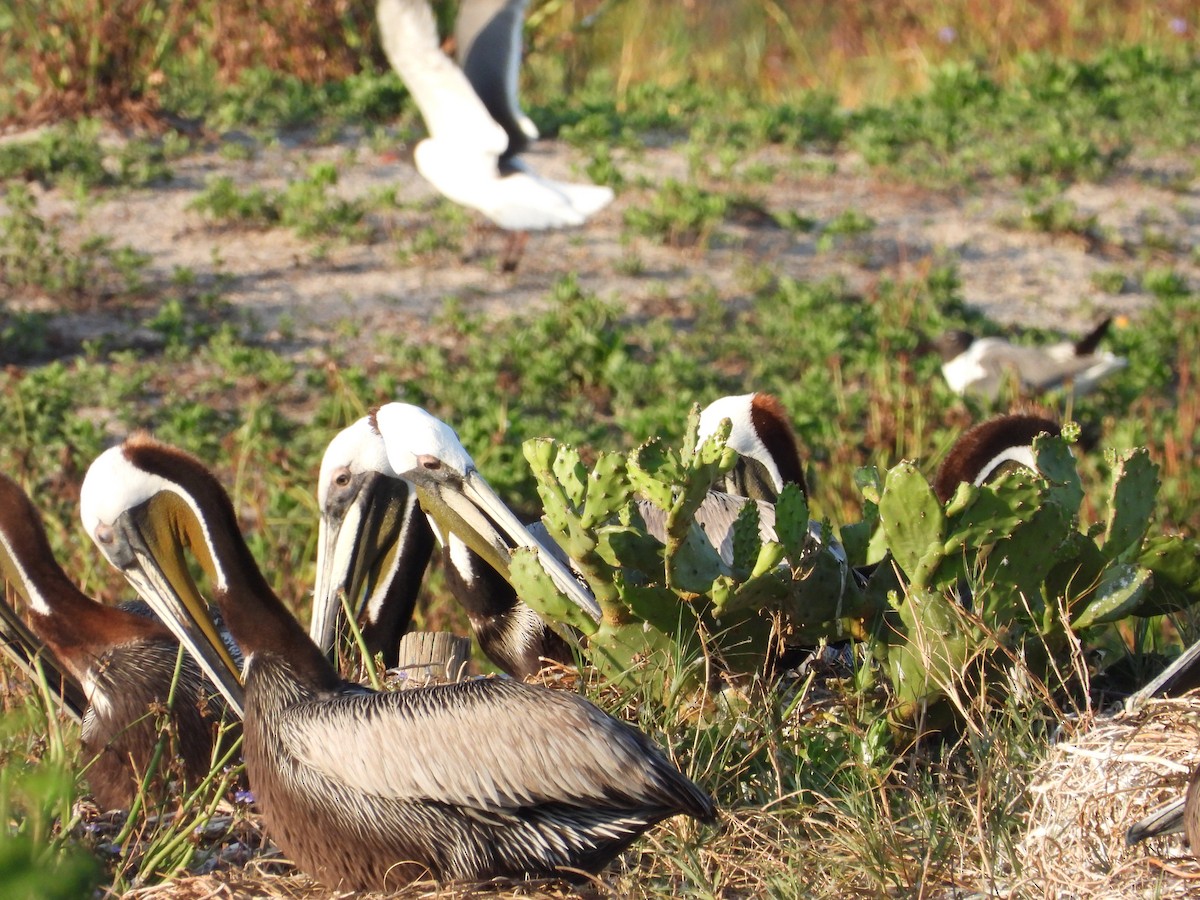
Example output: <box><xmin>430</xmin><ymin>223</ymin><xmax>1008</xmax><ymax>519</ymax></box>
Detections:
<box><xmin>934</xmin><ymin>414</ymin><xmax>1062</xmax><ymax>503</ymax></box>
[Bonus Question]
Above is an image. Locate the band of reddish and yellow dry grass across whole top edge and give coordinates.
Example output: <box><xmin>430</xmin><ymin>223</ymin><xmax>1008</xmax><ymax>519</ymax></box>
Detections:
<box><xmin>0</xmin><ymin>0</ymin><xmax>1200</xmax><ymax>124</ymax></box>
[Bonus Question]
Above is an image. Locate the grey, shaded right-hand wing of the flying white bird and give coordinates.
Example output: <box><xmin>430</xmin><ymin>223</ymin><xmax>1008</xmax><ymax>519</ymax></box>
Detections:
<box><xmin>454</xmin><ymin>0</ymin><xmax>540</xmax><ymax>157</ymax></box>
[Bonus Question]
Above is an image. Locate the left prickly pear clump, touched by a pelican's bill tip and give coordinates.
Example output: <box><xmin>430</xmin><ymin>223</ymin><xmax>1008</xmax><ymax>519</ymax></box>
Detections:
<box><xmin>512</xmin><ymin>408</ymin><xmax>858</xmax><ymax>696</ymax></box>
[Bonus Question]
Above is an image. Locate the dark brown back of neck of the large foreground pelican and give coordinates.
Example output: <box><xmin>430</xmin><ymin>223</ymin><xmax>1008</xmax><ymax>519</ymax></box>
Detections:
<box><xmin>124</xmin><ymin>434</ymin><xmax>342</xmax><ymax>688</ymax></box>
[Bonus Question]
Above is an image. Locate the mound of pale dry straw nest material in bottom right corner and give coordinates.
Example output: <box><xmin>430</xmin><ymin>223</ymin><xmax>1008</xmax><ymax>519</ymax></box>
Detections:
<box><xmin>1015</xmin><ymin>694</ymin><xmax>1200</xmax><ymax>900</ymax></box>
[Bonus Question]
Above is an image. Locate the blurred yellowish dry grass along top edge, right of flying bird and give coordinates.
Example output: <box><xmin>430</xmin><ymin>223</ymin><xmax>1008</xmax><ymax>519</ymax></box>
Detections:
<box><xmin>547</xmin><ymin>0</ymin><xmax>1200</xmax><ymax>106</ymax></box>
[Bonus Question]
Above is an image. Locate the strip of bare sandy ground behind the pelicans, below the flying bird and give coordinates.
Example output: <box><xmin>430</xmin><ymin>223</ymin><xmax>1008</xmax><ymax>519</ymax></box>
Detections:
<box><xmin>8</xmin><ymin>131</ymin><xmax>1200</xmax><ymax>362</ymax></box>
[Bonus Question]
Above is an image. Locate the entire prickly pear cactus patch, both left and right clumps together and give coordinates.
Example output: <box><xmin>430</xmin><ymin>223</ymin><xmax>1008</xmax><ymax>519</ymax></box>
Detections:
<box><xmin>512</xmin><ymin>410</ymin><xmax>1200</xmax><ymax>728</ymax></box>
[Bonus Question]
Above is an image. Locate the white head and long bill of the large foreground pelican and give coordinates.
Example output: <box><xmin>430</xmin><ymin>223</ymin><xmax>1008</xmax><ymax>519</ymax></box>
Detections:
<box><xmin>79</xmin><ymin>436</ymin><xmax>244</xmax><ymax>716</ymax></box>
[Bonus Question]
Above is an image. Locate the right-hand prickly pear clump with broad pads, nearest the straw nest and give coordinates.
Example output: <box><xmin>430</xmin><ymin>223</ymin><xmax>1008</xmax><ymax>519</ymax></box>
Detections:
<box><xmin>860</xmin><ymin>430</ymin><xmax>1200</xmax><ymax>727</ymax></box>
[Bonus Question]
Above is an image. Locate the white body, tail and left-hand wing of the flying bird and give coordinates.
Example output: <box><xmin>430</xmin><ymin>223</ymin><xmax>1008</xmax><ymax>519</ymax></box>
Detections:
<box><xmin>377</xmin><ymin>0</ymin><xmax>612</xmax><ymax>230</ymax></box>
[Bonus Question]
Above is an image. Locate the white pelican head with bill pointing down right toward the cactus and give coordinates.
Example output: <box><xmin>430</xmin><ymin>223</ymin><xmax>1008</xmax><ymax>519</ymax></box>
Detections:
<box><xmin>370</xmin><ymin>403</ymin><xmax>600</xmax><ymax>622</ymax></box>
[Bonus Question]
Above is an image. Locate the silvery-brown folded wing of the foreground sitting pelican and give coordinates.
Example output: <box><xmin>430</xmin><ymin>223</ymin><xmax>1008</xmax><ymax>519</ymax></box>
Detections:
<box><xmin>277</xmin><ymin>679</ymin><xmax>713</xmax><ymax>818</ymax></box>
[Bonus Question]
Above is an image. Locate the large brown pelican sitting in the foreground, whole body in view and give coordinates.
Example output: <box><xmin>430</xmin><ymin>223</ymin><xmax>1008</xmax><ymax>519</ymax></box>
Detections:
<box><xmin>84</xmin><ymin>437</ymin><xmax>715</xmax><ymax>889</ymax></box>
